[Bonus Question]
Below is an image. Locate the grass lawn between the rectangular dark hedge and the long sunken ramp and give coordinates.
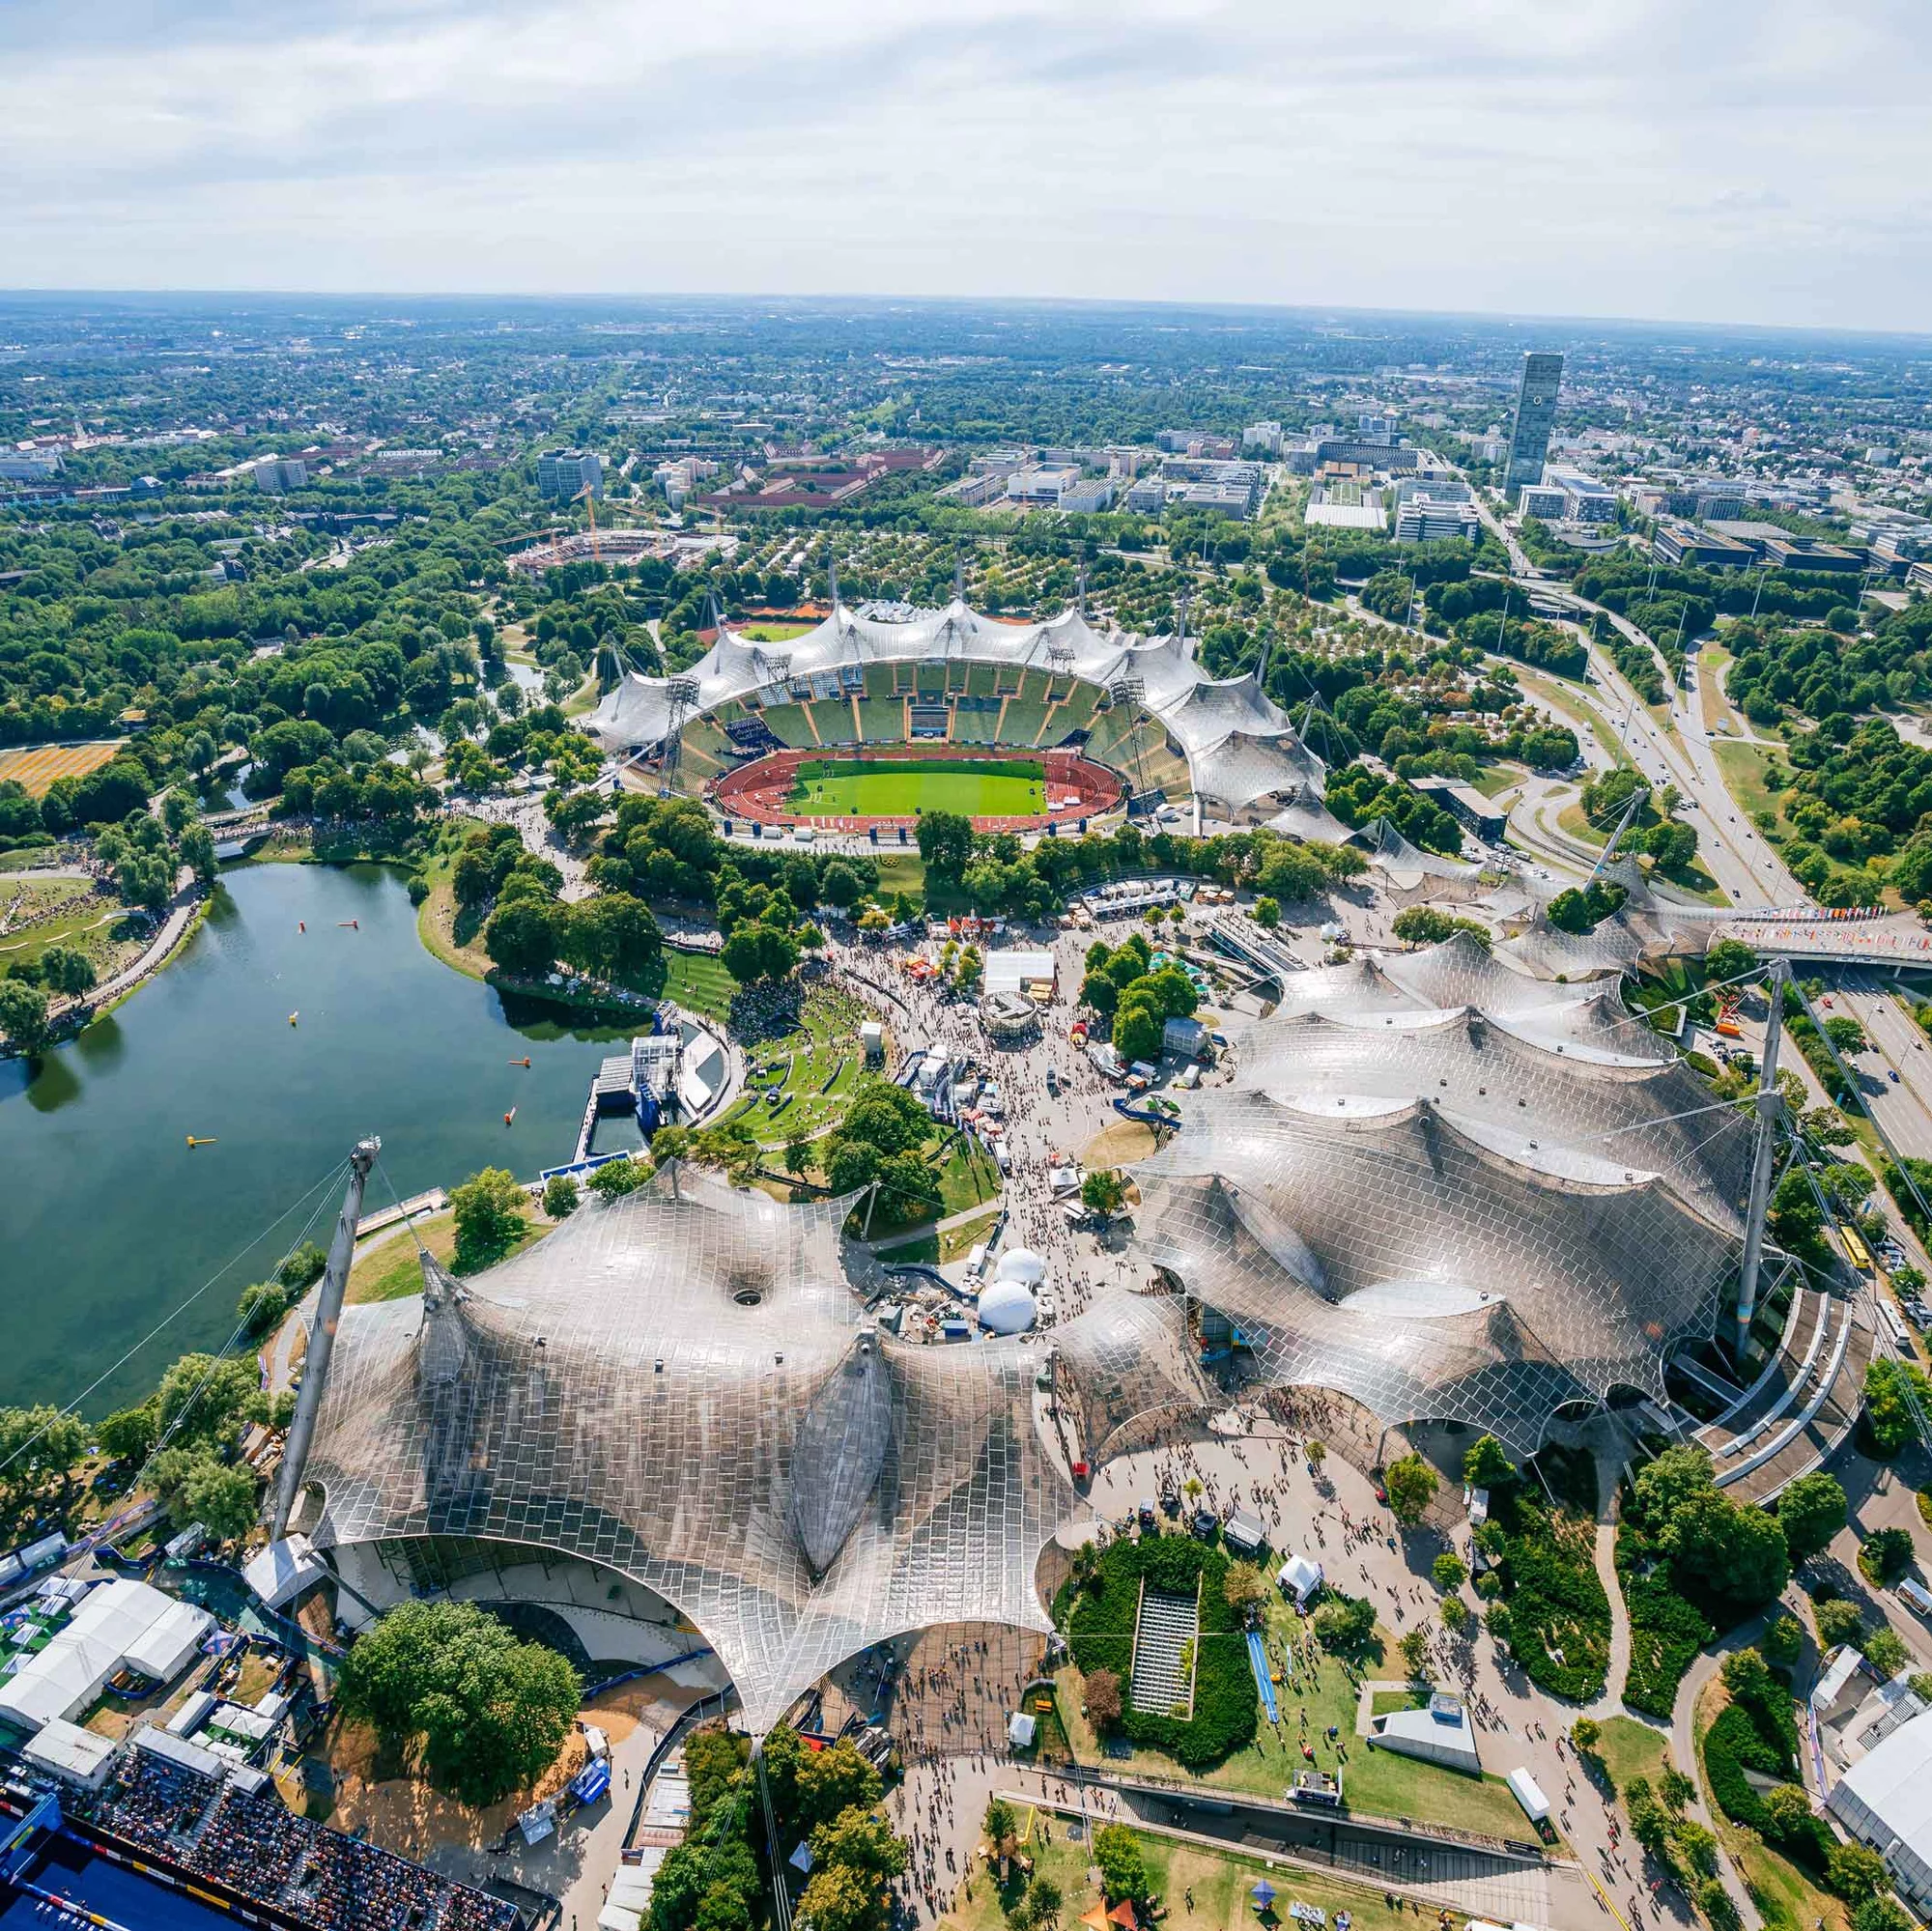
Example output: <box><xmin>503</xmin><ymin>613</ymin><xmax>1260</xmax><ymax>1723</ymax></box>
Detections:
<box><xmin>1059</xmin><ymin>1599</ymin><xmax>1524</xmax><ymax>1838</ymax></box>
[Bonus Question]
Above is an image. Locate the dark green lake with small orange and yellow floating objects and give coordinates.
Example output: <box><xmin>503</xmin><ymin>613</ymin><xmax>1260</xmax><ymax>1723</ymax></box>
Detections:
<box><xmin>0</xmin><ymin>866</ymin><xmax>628</xmax><ymax>1415</ymax></box>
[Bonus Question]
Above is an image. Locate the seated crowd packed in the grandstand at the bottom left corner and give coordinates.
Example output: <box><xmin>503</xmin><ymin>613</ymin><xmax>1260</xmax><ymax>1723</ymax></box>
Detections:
<box><xmin>79</xmin><ymin>1751</ymin><xmax>520</xmax><ymax>1931</ymax></box>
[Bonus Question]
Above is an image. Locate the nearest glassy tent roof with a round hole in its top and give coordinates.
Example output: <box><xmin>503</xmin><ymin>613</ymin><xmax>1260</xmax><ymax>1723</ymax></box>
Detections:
<box><xmin>307</xmin><ymin>1172</ymin><xmax>1208</xmax><ymax>1730</ymax></box>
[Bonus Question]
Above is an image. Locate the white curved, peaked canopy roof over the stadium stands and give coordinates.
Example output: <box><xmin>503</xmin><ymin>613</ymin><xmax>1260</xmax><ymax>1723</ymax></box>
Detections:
<box><xmin>589</xmin><ymin>601</ymin><xmax>1323</xmax><ymax>809</ymax></box>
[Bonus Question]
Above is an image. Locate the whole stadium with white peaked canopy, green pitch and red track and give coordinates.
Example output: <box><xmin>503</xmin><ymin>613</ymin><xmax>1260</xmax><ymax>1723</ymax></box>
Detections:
<box><xmin>589</xmin><ymin>601</ymin><xmax>1321</xmax><ymax>831</ymax></box>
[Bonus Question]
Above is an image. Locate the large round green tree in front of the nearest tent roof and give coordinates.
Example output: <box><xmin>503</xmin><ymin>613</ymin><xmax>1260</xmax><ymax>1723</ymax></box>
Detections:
<box><xmin>336</xmin><ymin>1603</ymin><xmax>582</xmax><ymax>1803</ymax></box>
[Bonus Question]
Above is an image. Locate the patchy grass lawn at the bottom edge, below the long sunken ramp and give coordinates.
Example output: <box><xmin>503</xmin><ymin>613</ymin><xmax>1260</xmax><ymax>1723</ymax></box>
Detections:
<box><xmin>939</xmin><ymin>1805</ymin><xmax>1389</xmax><ymax>1931</ymax></box>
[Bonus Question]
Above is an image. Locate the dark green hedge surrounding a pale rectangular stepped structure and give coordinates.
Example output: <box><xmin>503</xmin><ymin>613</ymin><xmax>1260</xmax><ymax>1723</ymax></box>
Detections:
<box><xmin>1057</xmin><ymin>1535</ymin><xmax>1262</xmax><ymax>1771</ymax></box>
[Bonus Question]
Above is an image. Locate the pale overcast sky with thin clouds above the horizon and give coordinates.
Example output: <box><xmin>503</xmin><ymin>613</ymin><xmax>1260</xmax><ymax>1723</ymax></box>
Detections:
<box><xmin>0</xmin><ymin>0</ymin><xmax>1932</xmax><ymax>330</ymax></box>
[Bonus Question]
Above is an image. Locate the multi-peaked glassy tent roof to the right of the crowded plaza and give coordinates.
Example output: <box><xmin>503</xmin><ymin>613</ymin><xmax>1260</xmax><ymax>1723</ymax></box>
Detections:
<box><xmin>1136</xmin><ymin>937</ymin><xmax>1750</xmax><ymax>1448</ymax></box>
